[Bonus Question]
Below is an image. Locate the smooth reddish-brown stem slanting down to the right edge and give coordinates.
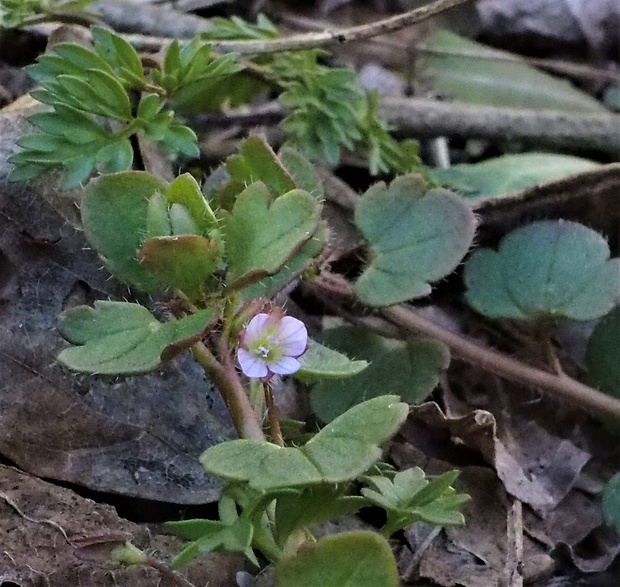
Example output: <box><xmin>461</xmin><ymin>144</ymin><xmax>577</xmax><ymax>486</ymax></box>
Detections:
<box><xmin>382</xmin><ymin>306</ymin><xmax>620</xmax><ymax>421</ymax></box>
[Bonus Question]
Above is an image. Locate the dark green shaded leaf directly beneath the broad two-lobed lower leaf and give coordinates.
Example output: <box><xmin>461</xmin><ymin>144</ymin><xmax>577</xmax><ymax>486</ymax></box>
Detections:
<box><xmin>275</xmin><ymin>485</ymin><xmax>366</xmax><ymax>546</ymax></box>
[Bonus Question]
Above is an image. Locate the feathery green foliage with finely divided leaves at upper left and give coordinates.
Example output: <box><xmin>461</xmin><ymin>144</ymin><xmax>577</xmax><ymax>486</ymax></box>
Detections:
<box><xmin>11</xmin><ymin>18</ymin><xmax>420</xmax><ymax>189</ymax></box>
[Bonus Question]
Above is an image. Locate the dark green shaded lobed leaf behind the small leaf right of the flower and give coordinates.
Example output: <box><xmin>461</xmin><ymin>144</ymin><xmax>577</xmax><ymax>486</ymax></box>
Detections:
<box><xmin>312</xmin><ymin>326</ymin><xmax>450</xmax><ymax>422</ymax></box>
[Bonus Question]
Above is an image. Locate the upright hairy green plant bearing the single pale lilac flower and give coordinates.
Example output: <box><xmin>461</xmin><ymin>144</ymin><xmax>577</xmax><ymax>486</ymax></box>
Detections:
<box><xmin>47</xmin><ymin>137</ymin><xmax>473</xmax><ymax>586</ymax></box>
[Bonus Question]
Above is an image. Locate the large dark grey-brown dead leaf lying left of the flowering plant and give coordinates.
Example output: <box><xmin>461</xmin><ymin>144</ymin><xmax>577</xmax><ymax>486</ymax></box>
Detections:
<box><xmin>0</xmin><ymin>96</ymin><xmax>231</xmax><ymax>503</ymax></box>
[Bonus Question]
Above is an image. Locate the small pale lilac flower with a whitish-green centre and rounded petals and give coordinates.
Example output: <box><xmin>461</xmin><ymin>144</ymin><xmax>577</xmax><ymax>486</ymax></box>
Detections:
<box><xmin>237</xmin><ymin>311</ymin><xmax>308</xmax><ymax>380</ymax></box>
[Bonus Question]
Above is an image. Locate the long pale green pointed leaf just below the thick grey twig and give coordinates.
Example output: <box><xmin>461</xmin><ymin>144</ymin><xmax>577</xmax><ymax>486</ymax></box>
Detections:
<box><xmin>428</xmin><ymin>153</ymin><xmax>600</xmax><ymax>200</ymax></box>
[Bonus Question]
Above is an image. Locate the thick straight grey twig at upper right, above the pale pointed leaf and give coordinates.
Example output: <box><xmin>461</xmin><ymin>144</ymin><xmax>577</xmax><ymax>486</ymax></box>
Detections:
<box><xmin>379</xmin><ymin>97</ymin><xmax>620</xmax><ymax>155</ymax></box>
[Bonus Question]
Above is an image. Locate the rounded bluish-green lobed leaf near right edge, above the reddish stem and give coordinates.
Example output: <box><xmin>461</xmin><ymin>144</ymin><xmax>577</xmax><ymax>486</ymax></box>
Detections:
<box><xmin>465</xmin><ymin>220</ymin><xmax>620</xmax><ymax>320</ymax></box>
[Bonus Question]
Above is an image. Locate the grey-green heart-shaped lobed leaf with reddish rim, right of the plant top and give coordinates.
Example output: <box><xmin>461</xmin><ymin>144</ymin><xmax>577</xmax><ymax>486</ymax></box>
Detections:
<box><xmin>355</xmin><ymin>175</ymin><xmax>476</xmax><ymax>306</ymax></box>
